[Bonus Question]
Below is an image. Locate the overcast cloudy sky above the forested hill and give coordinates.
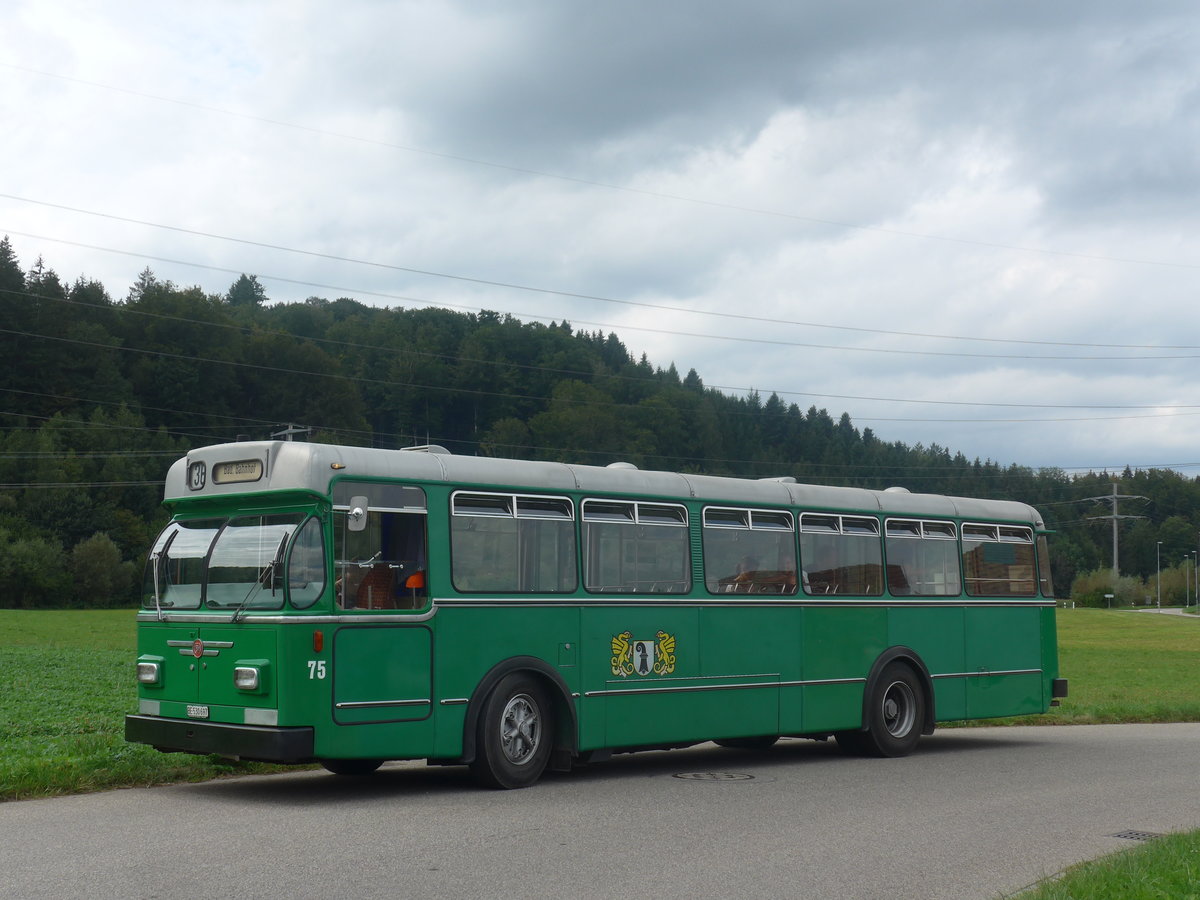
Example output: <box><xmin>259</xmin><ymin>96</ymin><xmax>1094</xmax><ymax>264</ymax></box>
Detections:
<box><xmin>0</xmin><ymin>0</ymin><xmax>1200</xmax><ymax>475</ymax></box>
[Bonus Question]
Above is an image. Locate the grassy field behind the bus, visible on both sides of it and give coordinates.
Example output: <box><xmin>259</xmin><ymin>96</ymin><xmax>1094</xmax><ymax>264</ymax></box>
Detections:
<box><xmin>0</xmin><ymin>610</ymin><xmax>1200</xmax><ymax>800</ymax></box>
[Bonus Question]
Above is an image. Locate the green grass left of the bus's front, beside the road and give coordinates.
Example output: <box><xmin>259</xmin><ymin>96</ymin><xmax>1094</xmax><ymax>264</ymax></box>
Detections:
<box><xmin>0</xmin><ymin>610</ymin><xmax>294</xmax><ymax>800</ymax></box>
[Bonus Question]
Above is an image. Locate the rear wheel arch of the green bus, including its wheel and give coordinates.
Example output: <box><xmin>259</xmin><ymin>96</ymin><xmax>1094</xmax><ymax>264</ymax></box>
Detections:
<box><xmin>836</xmin><ymin>647</ymin><xmax>936</xmax><ymax>756</ymax></box>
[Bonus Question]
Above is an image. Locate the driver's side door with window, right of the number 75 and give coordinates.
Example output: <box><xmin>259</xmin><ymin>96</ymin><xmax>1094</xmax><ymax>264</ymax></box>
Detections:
<box><xmin>331</xmin><ymin>481</ymin><xmax>433</xmax><ymax>725</ymax></box>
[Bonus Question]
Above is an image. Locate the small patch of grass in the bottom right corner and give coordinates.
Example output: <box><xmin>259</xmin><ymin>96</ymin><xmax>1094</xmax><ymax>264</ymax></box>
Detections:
<box><xmin>1009</xmin><ymin>832</ymin><xmax>1200</xmax><ymax>900</ymax></box>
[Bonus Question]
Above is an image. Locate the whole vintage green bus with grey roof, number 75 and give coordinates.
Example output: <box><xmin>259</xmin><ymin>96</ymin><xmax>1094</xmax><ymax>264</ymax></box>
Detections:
<box><xmin>125</xmin><ymin>442</ymin><xmax>1067</xmax><ymax>788</ymax></box>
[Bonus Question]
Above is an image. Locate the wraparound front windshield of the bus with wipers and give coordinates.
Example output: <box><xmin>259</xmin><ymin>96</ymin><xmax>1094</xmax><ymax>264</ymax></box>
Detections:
<box><xmin>142</xmin><ymin>512</ymin><xmax>324</xmax><ymax>612</ymax></box>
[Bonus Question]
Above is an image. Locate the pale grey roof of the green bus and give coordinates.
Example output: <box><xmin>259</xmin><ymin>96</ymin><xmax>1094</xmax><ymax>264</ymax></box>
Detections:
<box><xmin>163</xmin><ymin>440</ymin><xmax>1044</xmax><ymax>528</ymax></box>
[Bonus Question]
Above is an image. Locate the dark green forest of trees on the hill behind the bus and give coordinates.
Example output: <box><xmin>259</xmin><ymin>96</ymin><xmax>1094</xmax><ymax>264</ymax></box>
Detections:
<box><xmin>0</xmin><ymin>238</ymin><xmax>1200</xmax><ymax>607</ymax></box>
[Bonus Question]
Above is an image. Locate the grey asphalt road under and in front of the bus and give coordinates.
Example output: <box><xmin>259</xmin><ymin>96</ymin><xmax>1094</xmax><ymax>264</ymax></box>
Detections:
<box><xmin>0</xmin><ymin>725</ymin><xmax>1200</xmax><ymax>900</ymax></box>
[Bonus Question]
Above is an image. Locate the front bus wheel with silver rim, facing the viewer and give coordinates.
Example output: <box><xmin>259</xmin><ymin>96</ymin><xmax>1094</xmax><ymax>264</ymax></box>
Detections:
<box><xmin>470</xmin><ymin>672</ymin><xmax>554</xmax><ymax>790</ymax></box>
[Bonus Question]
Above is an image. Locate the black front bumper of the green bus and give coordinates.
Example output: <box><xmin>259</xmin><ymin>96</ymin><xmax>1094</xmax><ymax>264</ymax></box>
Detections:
<box><xmin>125</xmin><ymin>715</ymin><xmax>314</xmax><ymax>763</ymax></box>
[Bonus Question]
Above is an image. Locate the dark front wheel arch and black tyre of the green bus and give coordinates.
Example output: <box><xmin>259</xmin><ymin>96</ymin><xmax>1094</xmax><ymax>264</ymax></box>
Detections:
<box><xmin>462</xmin><ymin>656</ymin><xmax>578</xmax><ymax>787</ymax></box>
